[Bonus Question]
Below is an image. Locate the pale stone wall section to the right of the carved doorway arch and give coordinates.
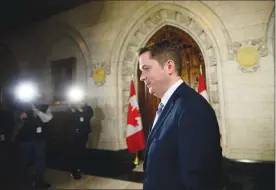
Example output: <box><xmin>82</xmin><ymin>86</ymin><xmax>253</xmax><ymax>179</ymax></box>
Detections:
<box><xmin>205</xmin><ymin>1</ymin><xmax>275</xmax><ymax>160</ymax></box>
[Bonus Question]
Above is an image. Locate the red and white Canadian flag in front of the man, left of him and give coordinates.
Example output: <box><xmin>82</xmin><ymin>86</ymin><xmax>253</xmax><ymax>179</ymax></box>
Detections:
<box><xmin>126</xmin><ymin>80</ymin><xmax>145</xmax><ymax>153</ymax></box>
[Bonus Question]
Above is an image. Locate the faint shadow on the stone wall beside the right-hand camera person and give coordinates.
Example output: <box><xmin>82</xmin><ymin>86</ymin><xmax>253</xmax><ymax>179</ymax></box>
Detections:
<box><xmin>87</xmin><ymin>107</ymin><xmax>105</xmax><ymax>149</ymax></box>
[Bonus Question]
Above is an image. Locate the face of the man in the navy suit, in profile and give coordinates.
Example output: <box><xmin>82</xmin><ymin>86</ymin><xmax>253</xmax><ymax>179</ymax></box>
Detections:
<box><xmin>139</xmin><ymin>52</ymin><xmax>169</xmax><ymax>98</ymax></box>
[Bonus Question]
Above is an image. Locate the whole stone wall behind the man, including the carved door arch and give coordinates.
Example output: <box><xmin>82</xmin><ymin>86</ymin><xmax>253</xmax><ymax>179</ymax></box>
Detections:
<box><xmin>1</xmin><ymin>1</ymin><xmax>275</xmax><ymax>160</ymax></box>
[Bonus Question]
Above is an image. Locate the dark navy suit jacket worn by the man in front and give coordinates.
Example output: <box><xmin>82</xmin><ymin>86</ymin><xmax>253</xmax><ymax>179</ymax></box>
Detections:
<box><xmin>143</xmin><ymin>83</ymin><xmax>222</xmax><ymax>190</ymax></box>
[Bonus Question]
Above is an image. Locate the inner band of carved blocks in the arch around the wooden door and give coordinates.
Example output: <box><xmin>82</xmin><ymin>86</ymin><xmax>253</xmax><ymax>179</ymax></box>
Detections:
<box><xmin>121</xmin><ymin>8</ymin><xmax>223</xmax><ymax>134</ymax></box>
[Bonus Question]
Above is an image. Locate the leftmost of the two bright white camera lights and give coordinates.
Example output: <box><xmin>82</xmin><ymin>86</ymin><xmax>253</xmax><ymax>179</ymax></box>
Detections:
<box><xmin>15</xmin><ymin>82</ymin><xmax>38</xmax><ymax>102</ymax></box>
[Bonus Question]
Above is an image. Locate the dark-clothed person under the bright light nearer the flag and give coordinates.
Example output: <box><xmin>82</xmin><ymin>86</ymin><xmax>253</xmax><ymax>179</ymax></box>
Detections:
<box><xmin>69</xmin><ymin>103</ymin><xmax>93</xmax><ymax>179</ymax></box>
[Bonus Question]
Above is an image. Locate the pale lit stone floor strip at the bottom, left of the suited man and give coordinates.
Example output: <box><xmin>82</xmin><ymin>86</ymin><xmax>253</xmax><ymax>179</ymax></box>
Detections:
<box><xmin>45</xmin><ymin>164</ymin><xmax>142</xmax><ymax>189</ymax></box>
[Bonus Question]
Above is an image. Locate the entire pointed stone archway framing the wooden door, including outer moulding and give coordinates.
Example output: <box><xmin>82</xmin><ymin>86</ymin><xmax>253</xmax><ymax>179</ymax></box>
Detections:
<box><xmin>111</xmin><ymin>1</ymin><xmax>230</xmax><ymax>154</ymax></box>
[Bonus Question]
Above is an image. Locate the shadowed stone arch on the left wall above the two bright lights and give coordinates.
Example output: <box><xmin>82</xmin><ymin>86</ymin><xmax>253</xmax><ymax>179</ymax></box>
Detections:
<box><xmin>30</xmin><ymin>22</ymin><xmax>91</xmax><ymax>101</ymax></box>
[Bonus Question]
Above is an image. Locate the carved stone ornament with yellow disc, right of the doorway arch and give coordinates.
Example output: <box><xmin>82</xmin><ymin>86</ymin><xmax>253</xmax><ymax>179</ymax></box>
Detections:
<box><xmin>228</xmin><ymin>38</ymin><xmax>268</xmax><ymax>73</ymax></box>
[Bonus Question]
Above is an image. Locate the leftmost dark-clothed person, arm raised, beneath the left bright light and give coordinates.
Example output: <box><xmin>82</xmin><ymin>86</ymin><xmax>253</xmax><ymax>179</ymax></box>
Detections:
<box><xmin>12</xmin><ymin>98</ymin><xmax>53</xmax><ymax>189</ymax></box>
